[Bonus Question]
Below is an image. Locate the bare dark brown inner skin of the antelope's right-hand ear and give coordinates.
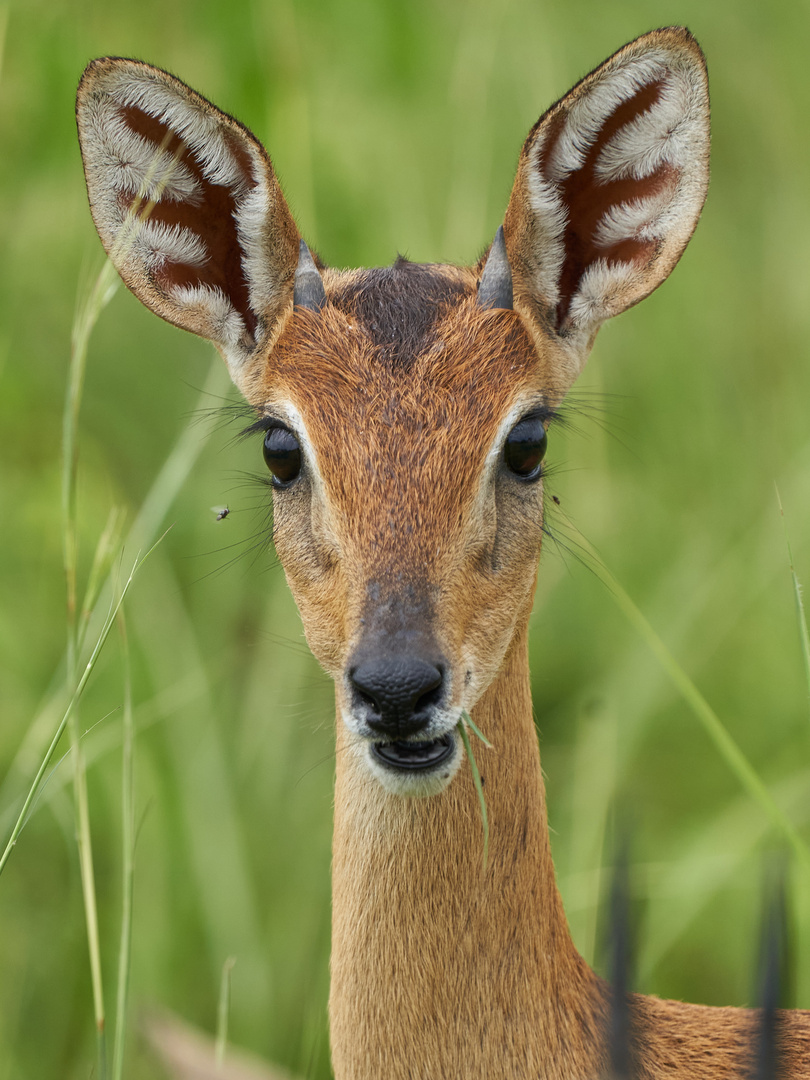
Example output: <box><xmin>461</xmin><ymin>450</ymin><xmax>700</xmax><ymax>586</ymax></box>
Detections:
<box><xmin>546</xmin><ymin>80</ymin><xmax>678</xmax><ymax>330</ymax></box>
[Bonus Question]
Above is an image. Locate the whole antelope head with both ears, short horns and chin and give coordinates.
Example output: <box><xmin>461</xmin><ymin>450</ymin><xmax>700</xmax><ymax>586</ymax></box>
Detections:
<box><xmin>78</xmin><ymin>28</ymin><xmax>708</xmax><ymax>795</ymax></box>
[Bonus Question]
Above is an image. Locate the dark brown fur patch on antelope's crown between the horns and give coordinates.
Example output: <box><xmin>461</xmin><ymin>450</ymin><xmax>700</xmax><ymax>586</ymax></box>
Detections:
<box><xmin>329</xmin><ymin>257</ymin><xmax>470</xmax><ymax>366</ymax></box>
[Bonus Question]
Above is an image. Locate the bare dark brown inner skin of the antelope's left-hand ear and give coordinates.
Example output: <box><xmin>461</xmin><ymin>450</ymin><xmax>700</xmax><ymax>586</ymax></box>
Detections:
<box><xmin>120</xmin><ymin>105</ymin><xmax>258</xmax><ymax>338</ymax></box>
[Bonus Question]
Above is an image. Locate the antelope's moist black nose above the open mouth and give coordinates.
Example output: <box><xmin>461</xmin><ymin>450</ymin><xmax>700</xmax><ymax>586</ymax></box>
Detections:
<box><xmin>349</xmin><ymin>657</ymin><xmax>444</xmax><ymax>739</ymax></box>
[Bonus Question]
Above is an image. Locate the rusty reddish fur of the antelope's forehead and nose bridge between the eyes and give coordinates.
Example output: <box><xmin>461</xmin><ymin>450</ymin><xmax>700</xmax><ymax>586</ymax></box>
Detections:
<box><xmin>259</xmin><ymin>275</ymin><xmax>544</xmax><ymax>561</ymax></box>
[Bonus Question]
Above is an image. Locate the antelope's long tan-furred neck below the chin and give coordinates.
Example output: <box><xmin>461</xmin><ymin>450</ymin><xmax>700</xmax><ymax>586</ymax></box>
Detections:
<box><xmin>329</xmin><ymin>626</ymin><xmax>604</xmax><ymax>1080</ymax></box>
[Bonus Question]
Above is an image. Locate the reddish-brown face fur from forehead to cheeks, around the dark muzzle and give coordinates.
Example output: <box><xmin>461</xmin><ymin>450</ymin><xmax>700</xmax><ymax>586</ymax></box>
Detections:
<box><xmin>248</xmin><ymin>266</ymin><xmax>558</xmax><ymax>708</ymax></box>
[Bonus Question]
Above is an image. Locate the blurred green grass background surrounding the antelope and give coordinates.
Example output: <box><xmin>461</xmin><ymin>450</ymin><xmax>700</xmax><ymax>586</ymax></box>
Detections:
<box><xmin>0</xmin><ymin>0</ymin><xmax>810</xmax><ymax>1080</ymax></box>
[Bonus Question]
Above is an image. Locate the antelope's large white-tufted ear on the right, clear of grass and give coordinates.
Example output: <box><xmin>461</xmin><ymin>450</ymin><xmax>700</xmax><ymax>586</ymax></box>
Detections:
<box><xmin>504</xmin><ymin>27</ymin><xmax>708</xmax><ymax>380</ymax></box>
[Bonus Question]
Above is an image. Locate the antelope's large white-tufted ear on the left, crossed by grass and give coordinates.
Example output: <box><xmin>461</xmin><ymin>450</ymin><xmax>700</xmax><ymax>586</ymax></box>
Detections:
<box><xmin>77</xmin><ymin>58</ymin><xmax>299</xmax><ymax>383</ymax></box>
